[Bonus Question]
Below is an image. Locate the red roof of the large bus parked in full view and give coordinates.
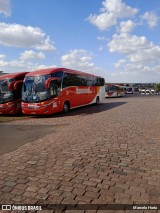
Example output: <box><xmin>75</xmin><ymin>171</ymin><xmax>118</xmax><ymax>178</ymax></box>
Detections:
<box><xmin>27</xmin><ymin>67</ymin><xmax>100</xmax><ymax>77</ymax></box>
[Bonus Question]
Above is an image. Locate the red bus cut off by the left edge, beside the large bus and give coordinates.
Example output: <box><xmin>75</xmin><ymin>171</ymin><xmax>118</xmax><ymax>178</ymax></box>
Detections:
<box><xmin>0</xmin><ymin>72</ymin><xmax>28</xmax><ymax>114</ymax></box>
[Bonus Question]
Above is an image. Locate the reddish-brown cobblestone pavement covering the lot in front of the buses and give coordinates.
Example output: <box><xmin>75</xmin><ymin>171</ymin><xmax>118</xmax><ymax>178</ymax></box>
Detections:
<box><xmin>0</xmin><ymin>95</ymin><xmax>160</xmax><ymax>213</ymax></box>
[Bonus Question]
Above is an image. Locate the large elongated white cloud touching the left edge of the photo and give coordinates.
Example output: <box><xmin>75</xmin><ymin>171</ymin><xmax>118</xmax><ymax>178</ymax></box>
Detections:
<box><xmin>0</xmin><ymin>23</ymin><xmax>56</xmax><ymax>51</ymax></box>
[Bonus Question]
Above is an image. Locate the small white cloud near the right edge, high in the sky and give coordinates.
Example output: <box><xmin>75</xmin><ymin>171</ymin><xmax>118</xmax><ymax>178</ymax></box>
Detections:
<box><xmin>141</xmin><ymin>12</ymin><xmax>159</xmax><ymax>28</ymax></box>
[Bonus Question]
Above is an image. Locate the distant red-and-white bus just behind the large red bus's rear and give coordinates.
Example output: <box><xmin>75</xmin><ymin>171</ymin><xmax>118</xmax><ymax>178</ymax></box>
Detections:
<box><xmin>105</xmin><ymin>84</ymin><xmax>124</xmax><ymax>98</ymax></box>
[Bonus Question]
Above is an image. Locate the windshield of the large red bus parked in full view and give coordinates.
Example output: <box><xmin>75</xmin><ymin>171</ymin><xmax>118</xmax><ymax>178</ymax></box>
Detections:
<box><xmin>22</xmin><ymin>75</ymin><xmax>58</xmax><ymax>102</ymax></box>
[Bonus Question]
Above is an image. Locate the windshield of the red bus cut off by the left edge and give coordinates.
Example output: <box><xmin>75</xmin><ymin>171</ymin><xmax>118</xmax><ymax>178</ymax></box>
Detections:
<box><xmin>0</xmin><ymin>79</ymin><xmax>13</xmax><ymax>104</ymax></box>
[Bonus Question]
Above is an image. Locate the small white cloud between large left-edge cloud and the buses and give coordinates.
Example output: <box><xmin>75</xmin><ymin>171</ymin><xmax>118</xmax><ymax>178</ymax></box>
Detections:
<box><xmin>20</xmin><ymin>50</ymin><xmax>45</xmax><ymax>61</ymax></box>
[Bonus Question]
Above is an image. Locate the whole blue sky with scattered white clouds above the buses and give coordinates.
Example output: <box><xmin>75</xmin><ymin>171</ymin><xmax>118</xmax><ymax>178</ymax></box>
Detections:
<box><xmin>0</xmin><ymin>0</ymin><xmax>160</xmax><ymax>83</ymax></box>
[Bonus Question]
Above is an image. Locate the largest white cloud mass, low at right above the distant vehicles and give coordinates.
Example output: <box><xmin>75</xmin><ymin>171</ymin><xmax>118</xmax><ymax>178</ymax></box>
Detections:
<box><xmin>108</xmin><ymin>33</ymin><xmax>160</xmax><ymax>82</ymax></box>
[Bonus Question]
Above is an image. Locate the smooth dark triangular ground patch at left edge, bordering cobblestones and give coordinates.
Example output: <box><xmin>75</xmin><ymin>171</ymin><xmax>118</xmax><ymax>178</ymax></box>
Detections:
<box><xmin>0</xmin><ymin>124</ymin><xmax>68</xmax><ymax>154</ymax></box>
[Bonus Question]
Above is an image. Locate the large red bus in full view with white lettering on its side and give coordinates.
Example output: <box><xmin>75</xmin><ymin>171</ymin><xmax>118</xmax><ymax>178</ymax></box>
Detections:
<box><xmin>22</xmin><ymin>68</ymin><xmax>105</xmax><ymax>114</ymax></box>
